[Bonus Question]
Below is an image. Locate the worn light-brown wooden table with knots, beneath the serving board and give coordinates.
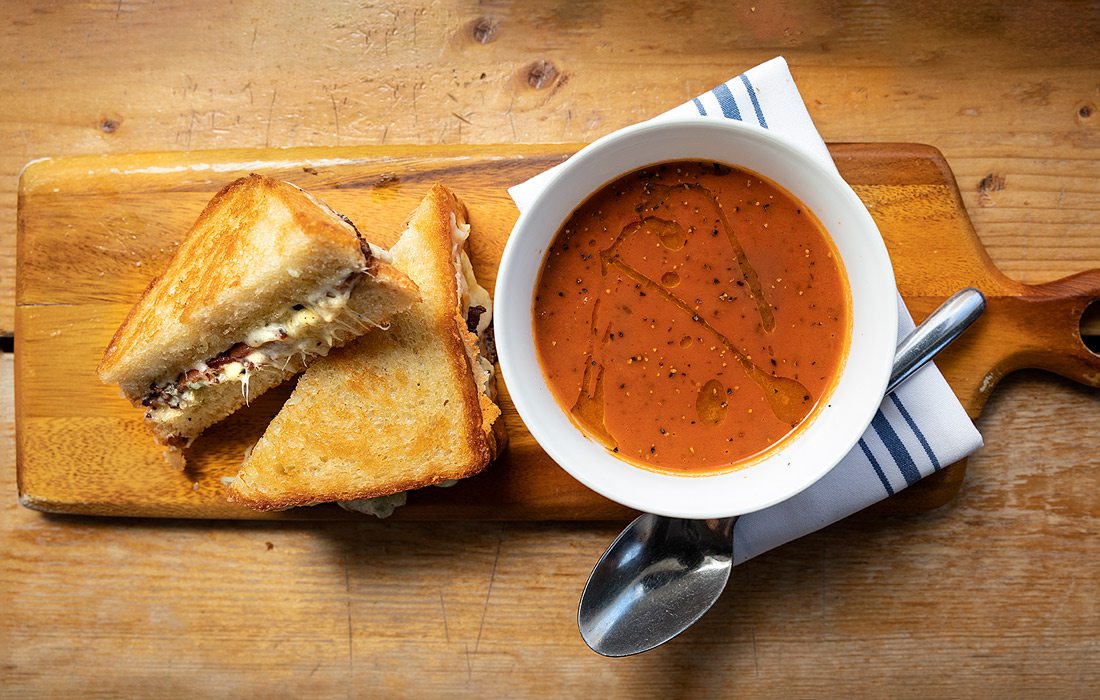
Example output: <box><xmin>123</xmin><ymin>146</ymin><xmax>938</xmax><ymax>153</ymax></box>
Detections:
<box><xmin>0</xmin><ymin>0</ymin><xmax>1100</xmax><ymax>698</ymax></box>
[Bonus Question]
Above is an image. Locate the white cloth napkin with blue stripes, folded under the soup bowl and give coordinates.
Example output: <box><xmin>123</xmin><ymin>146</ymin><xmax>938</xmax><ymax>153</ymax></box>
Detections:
<box><xmin>508</xmin><ymin>57</ymin><xmax>981</xmax><ymax>564</ymax></box>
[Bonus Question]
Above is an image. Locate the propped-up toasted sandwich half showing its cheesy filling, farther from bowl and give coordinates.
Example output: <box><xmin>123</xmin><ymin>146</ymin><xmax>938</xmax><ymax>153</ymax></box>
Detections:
<box><xmin>98</xmin><ymin>174</ymin><xmax>418</xmax><ymax>447</ymax></box>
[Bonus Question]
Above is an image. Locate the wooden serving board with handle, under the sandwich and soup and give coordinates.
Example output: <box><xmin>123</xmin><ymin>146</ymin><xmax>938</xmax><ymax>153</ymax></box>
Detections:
<box><xmin>15</xmin><ymin>144</ymin><xmax>1100</xmax><ymax>521</ymax></box>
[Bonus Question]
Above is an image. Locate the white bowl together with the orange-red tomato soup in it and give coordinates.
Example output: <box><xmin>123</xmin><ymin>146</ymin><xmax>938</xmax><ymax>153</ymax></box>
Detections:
<box><xmin>495</xmin><ymin>118</ymin><xmax>898</xmax><ymax>518</ymax></box>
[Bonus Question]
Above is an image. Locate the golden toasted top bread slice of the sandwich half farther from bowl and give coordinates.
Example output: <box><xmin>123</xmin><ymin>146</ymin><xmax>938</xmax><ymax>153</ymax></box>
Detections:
<box><xmin>97</xmin><ymin>174</ymin><xmax>366</xmax><ymax>385</ymax></box>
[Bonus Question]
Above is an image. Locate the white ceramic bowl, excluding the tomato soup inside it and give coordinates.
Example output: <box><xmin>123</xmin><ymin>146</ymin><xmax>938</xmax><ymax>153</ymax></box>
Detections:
<box><xmin>494</xmin><ymin>118</ymin><xmax>898</xmax><ymax>518</ymax></box>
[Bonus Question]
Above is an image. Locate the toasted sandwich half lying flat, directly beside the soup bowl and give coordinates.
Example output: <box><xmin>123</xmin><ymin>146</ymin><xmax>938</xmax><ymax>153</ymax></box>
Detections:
<box><xmin>229</xmin><ymin>185</ymin><xmax>505</xmax><ymax>511</ymax></box>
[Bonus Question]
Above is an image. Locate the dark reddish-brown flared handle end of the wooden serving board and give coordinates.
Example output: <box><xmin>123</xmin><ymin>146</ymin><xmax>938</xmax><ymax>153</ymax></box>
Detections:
<box><xmin>1016</xmin><ymin>269</ymin><xmax>1100</xmax><ymax>386</ymax></box>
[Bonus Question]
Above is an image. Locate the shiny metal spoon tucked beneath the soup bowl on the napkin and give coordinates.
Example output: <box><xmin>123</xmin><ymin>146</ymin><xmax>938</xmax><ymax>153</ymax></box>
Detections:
<box><xmin>576</xmin><ymin>288</ymin><xmax>986</xmax><ymax>656</ymax></box>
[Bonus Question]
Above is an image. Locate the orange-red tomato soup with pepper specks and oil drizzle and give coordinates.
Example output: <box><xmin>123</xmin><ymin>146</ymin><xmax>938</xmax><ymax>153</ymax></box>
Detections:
<box><xmin>534</xmin><ymin>161</ymin><xmax>850</xmax><ymax>473</ymax></box>
